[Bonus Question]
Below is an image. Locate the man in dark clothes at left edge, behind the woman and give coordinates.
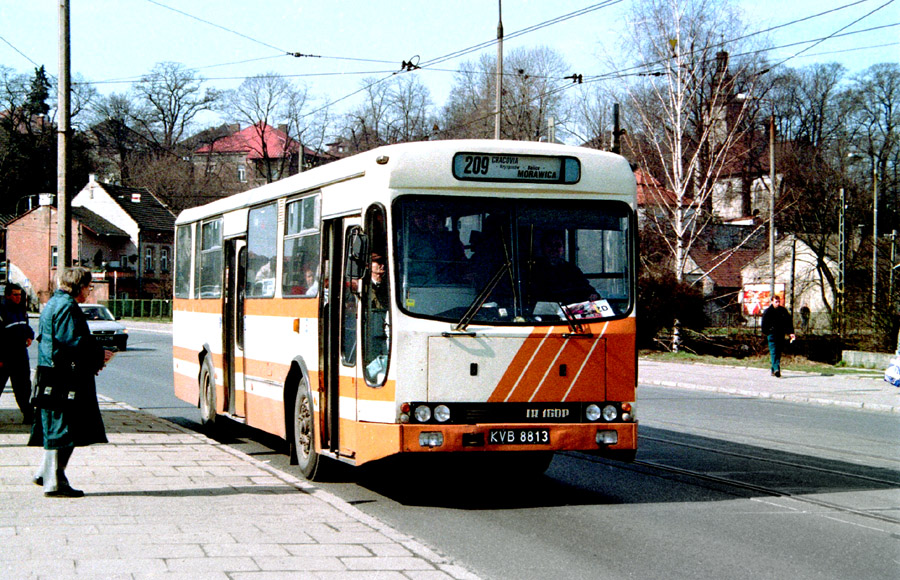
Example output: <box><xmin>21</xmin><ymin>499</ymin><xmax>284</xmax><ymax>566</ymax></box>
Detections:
<box><xmin>0</xmin><ymin>284</ymin><xmax>34</xmax><ymax>424</ymax></box>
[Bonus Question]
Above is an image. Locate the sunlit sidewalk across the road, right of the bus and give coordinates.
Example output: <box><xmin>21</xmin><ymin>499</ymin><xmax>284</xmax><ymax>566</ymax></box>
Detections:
<box><xmin>638</xmin><ymin>359</ymin><xmax>900</xmax><ymax>413</ymax></box>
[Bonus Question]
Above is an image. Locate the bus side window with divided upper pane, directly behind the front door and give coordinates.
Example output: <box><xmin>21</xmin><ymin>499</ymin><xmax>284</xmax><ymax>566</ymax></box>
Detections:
<box><xmin>281</xmin><ymin>196</ymin><xmax>319</xmax><ymax>297</ymax></box>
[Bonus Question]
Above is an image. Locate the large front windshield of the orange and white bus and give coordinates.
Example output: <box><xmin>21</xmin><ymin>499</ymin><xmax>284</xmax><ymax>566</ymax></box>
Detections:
<box><xmin>394</xmin><ymin>195</ymin><xmax>634</xmax><ymax>325</ymax></box>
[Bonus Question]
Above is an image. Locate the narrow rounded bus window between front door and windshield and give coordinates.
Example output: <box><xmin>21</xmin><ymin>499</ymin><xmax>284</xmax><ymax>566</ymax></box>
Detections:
<box><xmin>362</xmin><ymin>206</ymin><xmax>391</xmax><ymax>387</ymax></box>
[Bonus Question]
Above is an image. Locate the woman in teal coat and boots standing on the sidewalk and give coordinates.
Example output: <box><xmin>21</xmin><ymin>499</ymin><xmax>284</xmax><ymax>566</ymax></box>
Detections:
<box><xmin>28</xmin><ymin>267</ymin><xmax>113</xmax><ymax>497</ymax></box>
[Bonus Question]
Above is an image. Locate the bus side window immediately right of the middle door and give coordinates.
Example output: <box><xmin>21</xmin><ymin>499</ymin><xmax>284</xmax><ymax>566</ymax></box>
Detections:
<box><xmin>246</xmin><ymin>203</ymin><xmax>278</xmax><ymax>298</ymax></box>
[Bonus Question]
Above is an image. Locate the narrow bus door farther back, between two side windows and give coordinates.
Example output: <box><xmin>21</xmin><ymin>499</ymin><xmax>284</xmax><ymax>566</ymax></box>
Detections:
<box><xmin>222</xmin><ymin>238</ymin><xmax>247</xmax><ymax>418</ymax></box>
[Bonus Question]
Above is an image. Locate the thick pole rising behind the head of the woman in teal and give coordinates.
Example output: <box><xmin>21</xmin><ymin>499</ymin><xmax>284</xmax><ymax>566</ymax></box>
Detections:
<box><xmin>56</xmin><ymin>0</ymin><xmax>72</xmax><ymax>271</ymax></box>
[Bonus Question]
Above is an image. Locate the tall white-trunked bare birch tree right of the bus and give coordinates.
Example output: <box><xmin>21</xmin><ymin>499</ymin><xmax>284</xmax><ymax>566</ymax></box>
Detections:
<box><xmin>626</xmin><ymin>0</ymin><xmax>759</xmax><ymax>281</ymax></box>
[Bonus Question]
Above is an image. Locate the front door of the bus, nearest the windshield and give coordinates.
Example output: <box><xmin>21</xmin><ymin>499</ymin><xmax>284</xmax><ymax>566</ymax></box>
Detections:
<box><xmin>319</xmin><ymin>216</ymin><xmax>365</xmax><ymax>457</ymax></box>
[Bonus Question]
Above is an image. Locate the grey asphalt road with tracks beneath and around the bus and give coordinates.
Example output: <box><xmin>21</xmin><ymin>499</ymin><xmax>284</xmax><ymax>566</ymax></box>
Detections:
<box><xmin>45</xmin><ymin>330</ymin><xmax>900</xmax><ymax>580</ymax></box>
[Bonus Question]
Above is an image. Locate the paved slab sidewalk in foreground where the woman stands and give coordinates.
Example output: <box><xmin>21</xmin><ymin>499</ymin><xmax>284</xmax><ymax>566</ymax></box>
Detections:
<box><xmin>0</xmin><ymin>396</ymin><xmax>475</xmax><ymax>580</ymax></box>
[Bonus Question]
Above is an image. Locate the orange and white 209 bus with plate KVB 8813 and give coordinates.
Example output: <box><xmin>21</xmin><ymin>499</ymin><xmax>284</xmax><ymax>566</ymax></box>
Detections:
<box><xmin>173</xmin><ymin>140</ymin><xmax>637</xmax><ymax>480</ymax></box>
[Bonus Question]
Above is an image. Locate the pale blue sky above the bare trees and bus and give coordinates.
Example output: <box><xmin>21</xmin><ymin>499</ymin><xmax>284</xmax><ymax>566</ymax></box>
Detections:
<box><xmin>0</xmin><ymin>0</ymin><xmax>900</xmax><ymax>133</ymax></box>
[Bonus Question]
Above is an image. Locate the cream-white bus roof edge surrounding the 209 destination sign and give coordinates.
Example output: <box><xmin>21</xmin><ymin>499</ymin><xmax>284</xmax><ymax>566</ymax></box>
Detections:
<box><xmin>176</xmin><ymin>139</ymin><xmax>636</xmax><ymax>224</ymax></box>
